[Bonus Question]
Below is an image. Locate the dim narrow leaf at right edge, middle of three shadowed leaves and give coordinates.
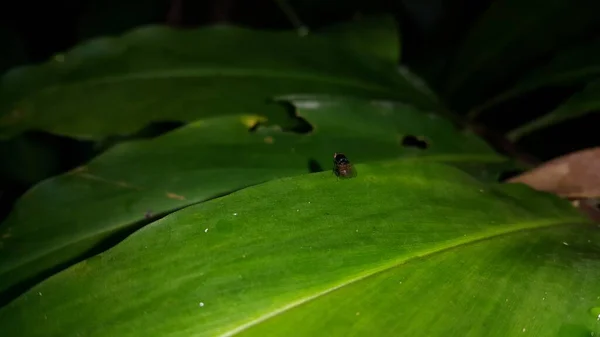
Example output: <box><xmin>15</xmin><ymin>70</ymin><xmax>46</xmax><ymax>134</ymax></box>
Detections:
<box><xmin>469</xmin><ymin>41</ymin><xmax>600</xmax><ymax>118</ymax></box>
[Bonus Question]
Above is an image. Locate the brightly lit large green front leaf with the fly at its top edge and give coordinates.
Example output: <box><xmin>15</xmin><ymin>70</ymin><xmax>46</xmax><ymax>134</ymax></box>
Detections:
<box><xmin>0</xmin><ymin>161</ymin><xmax>600</xmax><ymax>337</ymax></box>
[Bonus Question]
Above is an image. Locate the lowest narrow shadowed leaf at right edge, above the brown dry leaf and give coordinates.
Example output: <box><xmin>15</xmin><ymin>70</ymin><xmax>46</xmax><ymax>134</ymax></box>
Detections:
<box><xmin>507</xmin><ymin>80</ymin><xmax>600</xmax><ymax>142</ymax></box>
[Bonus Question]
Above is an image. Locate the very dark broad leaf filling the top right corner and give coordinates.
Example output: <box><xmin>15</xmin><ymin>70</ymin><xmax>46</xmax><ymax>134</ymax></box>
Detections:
<box><xmin>444</xmin><ymin>0</ymin><xmax>600</xmax><ymax>107</ymax></box>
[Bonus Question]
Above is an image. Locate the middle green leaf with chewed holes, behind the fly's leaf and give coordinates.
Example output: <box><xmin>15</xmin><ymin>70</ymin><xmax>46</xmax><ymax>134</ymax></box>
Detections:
<box><xmin>0</xmin><ymin>97</ymin><xmax>505</xmax><ymax>302</ymax></box>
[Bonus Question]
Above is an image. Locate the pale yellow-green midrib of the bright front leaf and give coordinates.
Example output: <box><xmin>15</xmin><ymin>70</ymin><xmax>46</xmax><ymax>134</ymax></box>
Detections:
<box><xmin>218</xmin><ymin>216</ymin><xmax>584</xmax><ymax>337</ymax></box>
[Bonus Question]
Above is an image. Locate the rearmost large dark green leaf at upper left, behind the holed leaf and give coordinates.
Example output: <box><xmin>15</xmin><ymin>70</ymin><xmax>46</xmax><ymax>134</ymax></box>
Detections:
<box><xmin>0</xmin><ymin>18</ymin><xmax>438</xmax><ymax>139</ymax></box>
